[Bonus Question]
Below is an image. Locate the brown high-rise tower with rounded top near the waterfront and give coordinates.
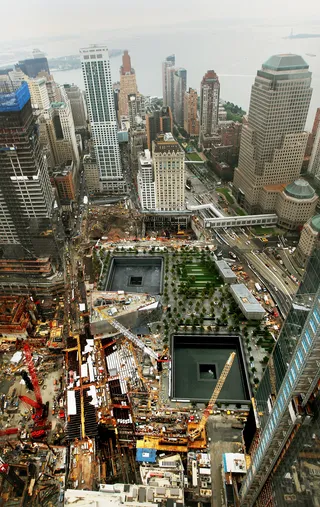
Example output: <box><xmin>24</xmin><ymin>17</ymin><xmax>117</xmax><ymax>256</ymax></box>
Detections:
<box><xmin>199</xmin><ymin>70</ymin><xmax>220</xmax><ymax>148</ymax></box>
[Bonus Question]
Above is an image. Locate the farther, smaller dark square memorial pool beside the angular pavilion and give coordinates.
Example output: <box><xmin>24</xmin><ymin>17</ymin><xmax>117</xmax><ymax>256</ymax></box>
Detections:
<box><xmin>105</xmin><ymin>255</ymin><xmax>164</xmax><ymax>294</ymax></box>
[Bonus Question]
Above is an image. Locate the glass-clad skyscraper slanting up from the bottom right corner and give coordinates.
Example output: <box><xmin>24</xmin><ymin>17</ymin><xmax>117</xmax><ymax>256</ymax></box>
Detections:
<box><xmin>239</xmin><ymin>248</ymin><xmax>320</xmax><ymax>507</ymax></box>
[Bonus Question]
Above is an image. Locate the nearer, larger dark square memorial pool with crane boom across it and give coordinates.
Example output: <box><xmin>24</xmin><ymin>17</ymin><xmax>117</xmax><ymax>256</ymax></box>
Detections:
<box><xmin>171</xmin><ymin>333</ymin><xmax>252</xmax><ymax>403</ymax></box>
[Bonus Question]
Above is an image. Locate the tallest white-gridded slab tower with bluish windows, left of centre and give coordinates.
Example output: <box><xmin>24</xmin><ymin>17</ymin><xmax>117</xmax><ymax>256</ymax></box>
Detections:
<box><xmin>80</xmin><ymin>45</ymin><xmax>125</xmax><ymax>192</ymax></box>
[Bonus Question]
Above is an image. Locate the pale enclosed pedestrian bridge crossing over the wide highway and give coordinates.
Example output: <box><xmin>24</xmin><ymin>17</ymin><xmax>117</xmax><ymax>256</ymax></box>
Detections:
<box><xmin>187</xmin><ymin>203</ymin><xmax>278</xmax><ymax>229</ymax></box>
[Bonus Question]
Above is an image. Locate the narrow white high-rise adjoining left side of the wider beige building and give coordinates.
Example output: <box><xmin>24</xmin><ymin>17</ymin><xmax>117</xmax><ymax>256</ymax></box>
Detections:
<box><xmin>137</xmin><ymin>150</ymin><xmax>156</xmax><ymax>210</ymax></box>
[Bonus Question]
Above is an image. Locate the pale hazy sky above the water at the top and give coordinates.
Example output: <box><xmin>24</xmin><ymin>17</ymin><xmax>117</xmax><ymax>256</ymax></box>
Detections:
<box><xmin>0</xmin><ymin>0</ymin><xmax>320</xmax><ymax>43</ymax></box>
